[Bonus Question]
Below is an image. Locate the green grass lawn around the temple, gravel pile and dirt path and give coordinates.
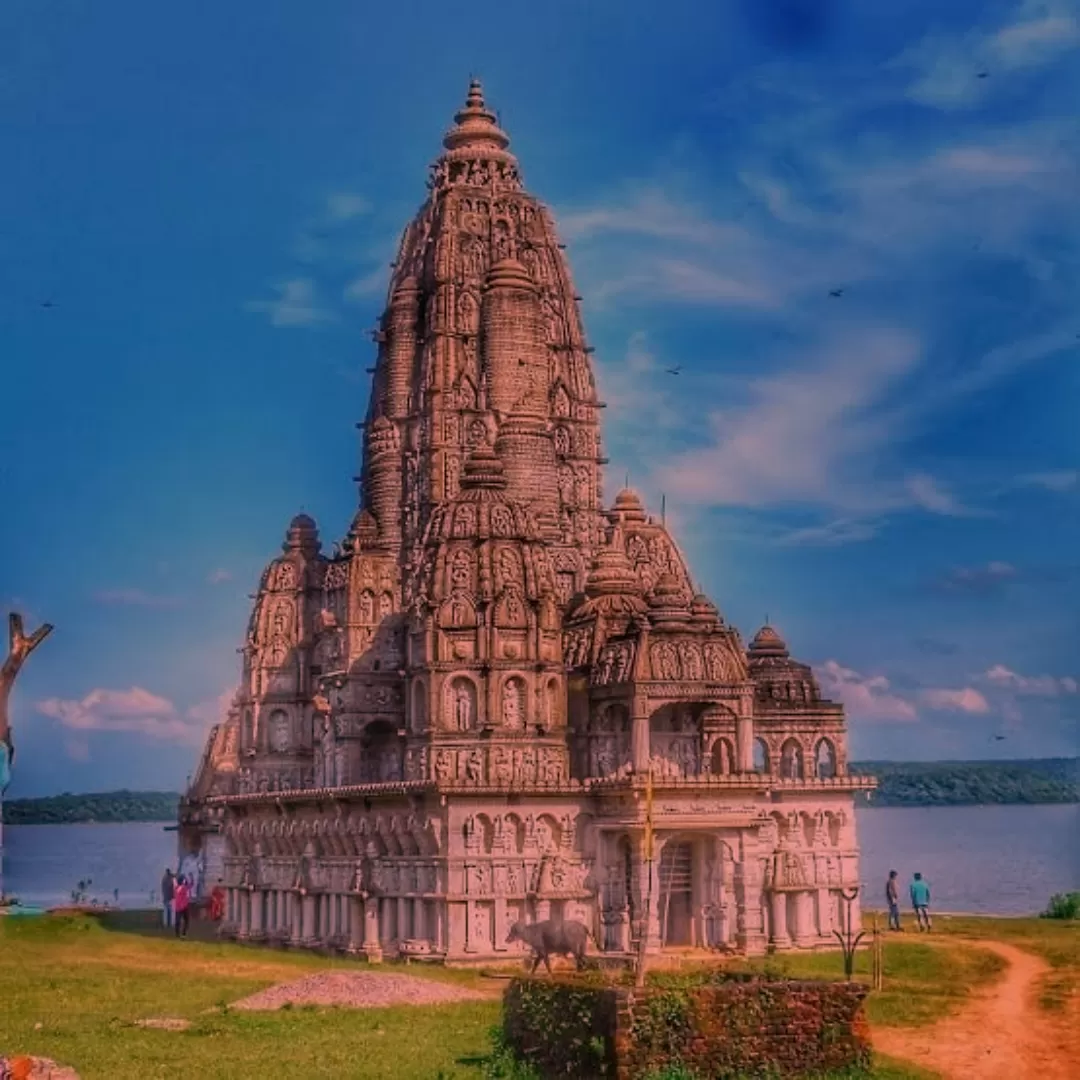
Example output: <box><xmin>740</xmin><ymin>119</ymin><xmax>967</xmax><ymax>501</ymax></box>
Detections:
<box><xmin>0</xmin><ymin>918</ymin><xmax>1078</xmax><ymax>1080</ymax></box>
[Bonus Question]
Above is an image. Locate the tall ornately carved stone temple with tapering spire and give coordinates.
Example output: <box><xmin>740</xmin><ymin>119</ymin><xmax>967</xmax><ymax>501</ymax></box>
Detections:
<box><xmin>180</xmin><ymin>82</ymin><xmax>874</xmax><ymax>961</ymax></box>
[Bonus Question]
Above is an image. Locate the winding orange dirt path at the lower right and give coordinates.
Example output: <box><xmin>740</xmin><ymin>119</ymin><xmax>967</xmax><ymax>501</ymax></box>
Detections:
<box><xmin>873</xmin><ymin>941</ymin><xmax>1080</xmax><ymax>1080</ymax></box>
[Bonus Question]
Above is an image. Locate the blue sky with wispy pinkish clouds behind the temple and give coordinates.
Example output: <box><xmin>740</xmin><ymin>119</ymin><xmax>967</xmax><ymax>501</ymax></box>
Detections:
<box><xmin>0</xmin><ymin>0</ymin><xmax>1080</xmax><ymax>795</ymax></box>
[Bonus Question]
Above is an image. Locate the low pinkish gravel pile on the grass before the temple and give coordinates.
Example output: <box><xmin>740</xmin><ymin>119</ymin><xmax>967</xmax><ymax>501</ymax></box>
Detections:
<box><xmin>232</xmin><ymin>971</ymin><xmax>485</xmax><ymax>1009</ymax></box>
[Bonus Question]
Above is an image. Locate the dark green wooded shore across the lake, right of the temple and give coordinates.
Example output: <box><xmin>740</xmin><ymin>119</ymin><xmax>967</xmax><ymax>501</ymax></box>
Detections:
<box><xmin>851</xmin><ymin>757</ymin><xmax>1080</xmax><ymax>807</ymax></box>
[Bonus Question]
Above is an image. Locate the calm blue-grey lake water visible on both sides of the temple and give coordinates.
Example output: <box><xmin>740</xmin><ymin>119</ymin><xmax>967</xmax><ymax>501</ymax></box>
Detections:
<box><xmin>4</xmin><ymin>806</ymin><xmax>1080</xmax><ymax>915</ymax></box>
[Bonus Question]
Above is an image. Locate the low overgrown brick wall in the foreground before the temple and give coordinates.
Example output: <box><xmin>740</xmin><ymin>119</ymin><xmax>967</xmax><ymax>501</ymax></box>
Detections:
<box><xmin>503</xmin><ymin>972</ymin><xmax>870</xmax><ymax>1080</ymax></box>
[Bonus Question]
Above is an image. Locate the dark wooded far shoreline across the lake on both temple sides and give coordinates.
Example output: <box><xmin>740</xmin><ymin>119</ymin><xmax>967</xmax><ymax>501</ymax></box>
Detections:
<box><xmin>3</xmin><ymin>757</ymin><xmax>1080</xmax><ymax>825</ymax></box>
